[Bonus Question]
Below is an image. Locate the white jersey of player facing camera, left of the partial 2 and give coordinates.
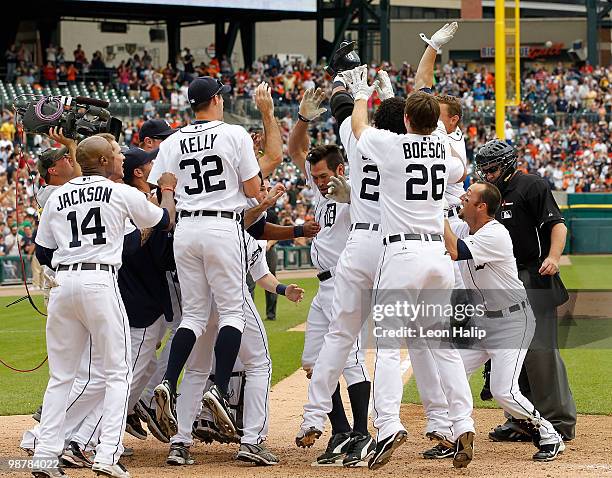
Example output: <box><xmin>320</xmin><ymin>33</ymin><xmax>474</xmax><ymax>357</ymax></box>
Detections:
<box><xmin>306</xmin><ymin>161</ymin><xmax>351</xmax><ymax>271</ymax></box>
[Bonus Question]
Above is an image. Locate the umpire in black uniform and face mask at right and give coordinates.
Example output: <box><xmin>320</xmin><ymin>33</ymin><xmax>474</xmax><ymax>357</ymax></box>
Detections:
<box><xmin>475</xmin><ymin>139</ymin><xmax>576</xmax><ymax>441</ymax></box>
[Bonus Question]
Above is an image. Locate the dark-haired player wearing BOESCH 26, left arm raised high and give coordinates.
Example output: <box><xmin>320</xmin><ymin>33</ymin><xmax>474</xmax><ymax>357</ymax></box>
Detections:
<box><xmin>345</xmin><ymin>66</ymin><xmax>474</xmax><ymax>469</ymax></box>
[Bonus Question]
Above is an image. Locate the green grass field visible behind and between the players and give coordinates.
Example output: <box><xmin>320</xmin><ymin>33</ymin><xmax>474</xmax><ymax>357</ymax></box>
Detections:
<box><xmin>0</xmin><ymin>256</ymin><xmax>612</xmax><ymax>415</ymax></box>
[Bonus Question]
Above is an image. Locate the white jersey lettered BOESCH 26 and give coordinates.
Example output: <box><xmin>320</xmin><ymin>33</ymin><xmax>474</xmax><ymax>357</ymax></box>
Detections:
<box><xmin>357</xmin><ymin>127</ymin><xmax>464</xmax><ymax>235</ymax></box>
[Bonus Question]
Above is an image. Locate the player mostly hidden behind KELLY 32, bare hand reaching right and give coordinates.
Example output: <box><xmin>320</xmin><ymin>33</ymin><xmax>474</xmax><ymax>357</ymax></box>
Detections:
<box><xmin>167</xmin><ymin>234</ymin><xmax>304</xmax><ymax>465</ymax></box>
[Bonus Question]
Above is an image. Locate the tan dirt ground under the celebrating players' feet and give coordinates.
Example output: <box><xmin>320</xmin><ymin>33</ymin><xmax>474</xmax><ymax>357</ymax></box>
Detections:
<box><xmin>0</xmin><ymin>371</ymin><xmax>612</xmax><ymax>478</ymax></box>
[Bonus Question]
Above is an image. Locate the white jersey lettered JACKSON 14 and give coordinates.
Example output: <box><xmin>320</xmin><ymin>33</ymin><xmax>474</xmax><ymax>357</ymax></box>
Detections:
<box><xmin>36</xmin><ymin>176</ymin><xmax>163</xmax><ymax>267</ymax></box>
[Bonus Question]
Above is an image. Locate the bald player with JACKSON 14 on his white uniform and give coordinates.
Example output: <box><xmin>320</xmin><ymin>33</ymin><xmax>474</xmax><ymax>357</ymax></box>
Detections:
<box><xmin>32</xmin><ymin>137</ymin><xmax>175</xmax><ymax>478</ymax></box>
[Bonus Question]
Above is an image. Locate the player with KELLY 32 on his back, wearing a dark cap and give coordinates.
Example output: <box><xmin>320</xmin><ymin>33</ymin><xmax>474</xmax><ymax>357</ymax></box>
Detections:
<box><xmin>149</xmin><ymin>77</ymin><xmax>261</xmax><ymax>436</ymax></box>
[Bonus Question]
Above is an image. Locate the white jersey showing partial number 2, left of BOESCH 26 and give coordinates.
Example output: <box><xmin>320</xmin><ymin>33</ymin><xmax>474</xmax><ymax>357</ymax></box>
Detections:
<box><xmin>340</xmin><ymin>116</ymin><xmax>380</xmax><ymax>224</ymax></box>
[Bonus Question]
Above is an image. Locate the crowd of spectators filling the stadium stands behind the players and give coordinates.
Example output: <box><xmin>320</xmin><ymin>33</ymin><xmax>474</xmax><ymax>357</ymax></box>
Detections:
<box><xmin>0</xmin><ymin>50</ymin><xmax>612</xmax><ymax>270</ymax></box>
